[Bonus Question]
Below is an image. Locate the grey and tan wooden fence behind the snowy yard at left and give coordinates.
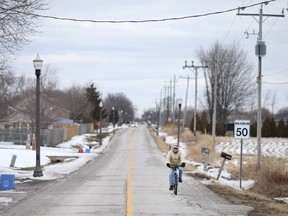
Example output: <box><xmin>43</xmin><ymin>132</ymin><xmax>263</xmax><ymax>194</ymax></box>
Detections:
<box><xmin>0</xmin><ymin>124</ymin><xmax>93</xmax><ymax>147</ymax></box>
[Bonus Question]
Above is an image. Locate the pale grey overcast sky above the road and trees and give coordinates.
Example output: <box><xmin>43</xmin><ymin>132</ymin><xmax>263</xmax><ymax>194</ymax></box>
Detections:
<box><xmin>14</xmin><ymin>0</ymin><xmax>288</xmax><ymax>114</ymax></box>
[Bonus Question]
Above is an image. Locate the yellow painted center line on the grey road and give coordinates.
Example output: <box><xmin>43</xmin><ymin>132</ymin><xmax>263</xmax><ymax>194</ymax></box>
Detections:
<box><xmin>126</xmin><ymin>134</ymin><xmax>134</xmax><ymax>216</ymax></box>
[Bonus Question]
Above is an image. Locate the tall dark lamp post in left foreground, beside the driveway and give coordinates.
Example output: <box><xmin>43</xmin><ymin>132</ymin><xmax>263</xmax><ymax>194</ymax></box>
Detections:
<box><xmin>33</xmin><ymin>54</ymin><xmax>43</xmax><ymax>177</ymax></box>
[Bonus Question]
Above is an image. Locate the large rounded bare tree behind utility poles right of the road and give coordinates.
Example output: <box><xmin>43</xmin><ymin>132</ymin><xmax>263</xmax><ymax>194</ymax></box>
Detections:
<box><xmin>197</xmin><ymin>42</ymin><xmax>254</xmax><ymax>123</ymax></box>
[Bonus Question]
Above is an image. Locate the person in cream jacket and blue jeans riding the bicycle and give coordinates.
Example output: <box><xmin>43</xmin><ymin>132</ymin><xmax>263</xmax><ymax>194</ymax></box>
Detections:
<box><xmin>166</xmin><ymin>145</ymin><xmax>185</xmax><ymax>190</ymax></box>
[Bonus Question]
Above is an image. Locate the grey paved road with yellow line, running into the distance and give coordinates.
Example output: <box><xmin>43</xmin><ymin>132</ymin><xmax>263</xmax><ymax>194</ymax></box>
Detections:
<box><xmin>1</xmin><ymin>126</ymin><xmax>252</xmax><ymax>216</ymax></box>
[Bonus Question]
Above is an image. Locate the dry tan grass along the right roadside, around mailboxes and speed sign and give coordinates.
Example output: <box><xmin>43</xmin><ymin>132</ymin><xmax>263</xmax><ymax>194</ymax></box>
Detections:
<box><xmin>148</xmin><ymin>124</ymin><xmax>288</xmax><ymax>216</ymax></box>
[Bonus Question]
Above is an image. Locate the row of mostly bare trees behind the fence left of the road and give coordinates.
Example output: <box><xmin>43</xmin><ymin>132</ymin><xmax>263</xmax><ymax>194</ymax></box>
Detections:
<box><xmin>0</xmin><ymin>65</ymin><xmax>136</xmax><ymax>128</ymax></box>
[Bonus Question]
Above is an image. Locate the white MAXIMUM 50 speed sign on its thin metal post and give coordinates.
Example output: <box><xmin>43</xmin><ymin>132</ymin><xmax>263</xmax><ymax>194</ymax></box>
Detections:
<box><xmin>234</xmin><ymin>120</ymin><xmax>250</xmax><ymax>188</ymax></box>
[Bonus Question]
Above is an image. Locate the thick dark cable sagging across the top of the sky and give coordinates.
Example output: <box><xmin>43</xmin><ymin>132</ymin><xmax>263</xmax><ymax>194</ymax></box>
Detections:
<box><xmin>17</xmin><ymin>0</ymin><xmax>276</xmax><ymax>24</ymax></box>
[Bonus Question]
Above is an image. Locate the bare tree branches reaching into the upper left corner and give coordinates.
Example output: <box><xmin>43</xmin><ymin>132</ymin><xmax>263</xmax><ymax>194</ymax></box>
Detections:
<box><xmin>0</xmin><ymin>0</ymin><xmax>46</xmax><ymax>117</ymax></box>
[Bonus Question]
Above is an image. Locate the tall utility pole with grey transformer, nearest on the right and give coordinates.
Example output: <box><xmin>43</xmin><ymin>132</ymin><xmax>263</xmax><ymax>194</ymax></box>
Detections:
<box><xmin>237</xmin><ymin>2</ymin><xmax>285</xmax><ymax>167</ymax></box>
